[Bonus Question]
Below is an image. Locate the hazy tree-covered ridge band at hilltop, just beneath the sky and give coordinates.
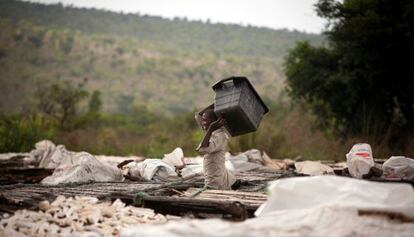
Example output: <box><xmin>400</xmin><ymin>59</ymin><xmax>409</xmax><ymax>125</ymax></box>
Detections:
<box><xmin>0</xmin><ymin>0</ymin><xmax>321</xmax><ymax>59</ymax></box>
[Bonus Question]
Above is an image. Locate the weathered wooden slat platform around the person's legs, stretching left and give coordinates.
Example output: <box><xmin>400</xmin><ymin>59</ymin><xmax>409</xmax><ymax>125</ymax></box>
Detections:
<box><xmin>0</xmin><ymin>169</ymin><xmax>283</xmax><ymax>216</ymax></box>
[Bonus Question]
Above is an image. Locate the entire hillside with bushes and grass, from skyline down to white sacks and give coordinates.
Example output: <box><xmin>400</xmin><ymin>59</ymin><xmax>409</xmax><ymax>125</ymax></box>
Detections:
<box><xmin>0</xmin><ymin>0</ymin><xmax>366</xmax><ymax>159</ymax></box>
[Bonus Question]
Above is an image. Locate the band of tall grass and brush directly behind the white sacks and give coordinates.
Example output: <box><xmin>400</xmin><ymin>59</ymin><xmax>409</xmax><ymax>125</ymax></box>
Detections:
<box><xmin>0</xmin><ymin>103</ymin><xmax>414</xmax><ymax>160</ymax></box>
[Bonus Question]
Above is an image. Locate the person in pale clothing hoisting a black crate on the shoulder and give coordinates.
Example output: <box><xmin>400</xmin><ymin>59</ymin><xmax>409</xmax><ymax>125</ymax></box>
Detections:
<box><xmin>196</xmin><ymin>105</ymin><xmax>240</xmax><ymax>190</ymax></box>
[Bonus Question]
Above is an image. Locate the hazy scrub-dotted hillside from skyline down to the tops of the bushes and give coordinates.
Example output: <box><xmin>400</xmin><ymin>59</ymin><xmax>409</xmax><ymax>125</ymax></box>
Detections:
<box><xmin>0</xmin><ymin>0</ymin><xmax>321</xmax><ymax>114</ymax></box>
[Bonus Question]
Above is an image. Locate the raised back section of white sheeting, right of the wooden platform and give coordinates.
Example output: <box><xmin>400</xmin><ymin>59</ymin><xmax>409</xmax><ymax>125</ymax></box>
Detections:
<box><xmin>256</xmin><ymin>176</ymin><xmax>414</xmax><ymax>218</ymax></box>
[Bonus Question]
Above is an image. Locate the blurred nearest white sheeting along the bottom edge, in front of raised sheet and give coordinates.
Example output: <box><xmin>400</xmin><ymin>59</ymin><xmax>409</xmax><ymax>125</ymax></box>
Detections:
<box><xmin>120</xmin><ymin>207</ymin><xmax>414</xmax><ymax>237</ymax></box>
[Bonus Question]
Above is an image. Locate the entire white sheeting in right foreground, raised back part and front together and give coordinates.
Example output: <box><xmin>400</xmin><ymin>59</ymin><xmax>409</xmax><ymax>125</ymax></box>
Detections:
<box><xmin>120</xmin><ymin>176</ymin><xmax>414</xmax><ymax>237</ymax></box>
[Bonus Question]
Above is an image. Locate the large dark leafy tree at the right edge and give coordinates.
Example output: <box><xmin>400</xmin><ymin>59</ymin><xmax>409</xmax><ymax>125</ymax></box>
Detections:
<box><xmin>284</xmin><ymin>0</ymin><xmax>414</xmax><ymax>148</ymax></box>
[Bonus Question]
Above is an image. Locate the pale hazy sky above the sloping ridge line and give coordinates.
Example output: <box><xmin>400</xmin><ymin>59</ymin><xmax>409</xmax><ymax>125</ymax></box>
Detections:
<box><xmin>31</xmin><ymin>0</ymin><xmax>325</xmax><ymax>33</ymax></box>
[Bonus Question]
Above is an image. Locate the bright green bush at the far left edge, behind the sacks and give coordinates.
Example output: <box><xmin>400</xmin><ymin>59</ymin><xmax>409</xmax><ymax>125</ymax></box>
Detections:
<box><xmin>0</xmin><ymin>115</ymin><xmax>55</xmax><ymax>153</ymax></box>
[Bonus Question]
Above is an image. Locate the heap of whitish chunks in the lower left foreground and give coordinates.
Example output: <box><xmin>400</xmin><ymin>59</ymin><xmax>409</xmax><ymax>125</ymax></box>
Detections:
<box><xmin>0</xmin><ymin>196</ymin><xmax>167</xmax><ymax>237</ymax></box>
